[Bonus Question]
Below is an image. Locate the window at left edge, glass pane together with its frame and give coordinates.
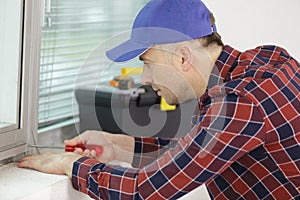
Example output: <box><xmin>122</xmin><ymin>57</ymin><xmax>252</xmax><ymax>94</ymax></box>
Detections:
<box><xmin>0</xmin><ymin>0</ymin><xmax>41</xmax><ymax>161</ymax></box>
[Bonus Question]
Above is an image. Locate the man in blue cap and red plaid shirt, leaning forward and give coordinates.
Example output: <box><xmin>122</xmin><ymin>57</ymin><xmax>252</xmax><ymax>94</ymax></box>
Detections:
<box><xmin>19</xmin><ymin>0</ymin><xmax>300</xmax><ymax>199</ymax></box>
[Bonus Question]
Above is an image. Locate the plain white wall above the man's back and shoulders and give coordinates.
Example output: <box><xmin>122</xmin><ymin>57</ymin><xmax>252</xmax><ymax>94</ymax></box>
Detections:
<box><xmin>203</xmin><ymin>0</ymin><xmax>300</xmax><ymax>61</ymax></box>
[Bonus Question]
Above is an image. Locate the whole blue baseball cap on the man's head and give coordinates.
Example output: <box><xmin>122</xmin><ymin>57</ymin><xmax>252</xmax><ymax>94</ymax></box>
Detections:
<box><xmin>106</xmin><ymin>0</ymin><xmax>216</xmax><ymax>62</ymax></box>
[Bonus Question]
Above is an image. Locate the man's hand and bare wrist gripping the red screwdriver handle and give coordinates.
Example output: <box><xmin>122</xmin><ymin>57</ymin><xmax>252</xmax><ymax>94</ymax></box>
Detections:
<box><xmin>65</xmin><ymin>131</ymin><xmax>134</xmax><ymax>163</ymax></box>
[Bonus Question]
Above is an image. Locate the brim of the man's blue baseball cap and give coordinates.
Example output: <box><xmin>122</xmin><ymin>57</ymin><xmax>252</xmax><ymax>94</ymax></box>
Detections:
<box><xmin>106</xmin><ymin>40</ymin><xmax>151</xmax><ymax>62</ymax></box>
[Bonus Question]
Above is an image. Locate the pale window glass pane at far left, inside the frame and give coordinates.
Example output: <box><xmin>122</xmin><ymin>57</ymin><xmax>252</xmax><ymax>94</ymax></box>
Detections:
<box><xmin>0</xmin><ymin>0</ymin><xmax>22</xmax><ymax>133</ymax></box>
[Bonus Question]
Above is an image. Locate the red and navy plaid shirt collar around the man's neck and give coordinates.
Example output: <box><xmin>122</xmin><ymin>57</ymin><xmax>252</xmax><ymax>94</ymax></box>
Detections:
<box><xmin>207</xmin><ymin>45</ymin><xmax>241</xmax><ymax>90</ymax></box>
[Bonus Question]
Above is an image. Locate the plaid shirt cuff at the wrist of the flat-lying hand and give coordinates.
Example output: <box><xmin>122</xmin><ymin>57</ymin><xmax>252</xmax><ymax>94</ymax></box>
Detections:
<box><xmin>72</xmin><ymin>157</ymin><xmax>99</xmax><ymax>193</ymax></box>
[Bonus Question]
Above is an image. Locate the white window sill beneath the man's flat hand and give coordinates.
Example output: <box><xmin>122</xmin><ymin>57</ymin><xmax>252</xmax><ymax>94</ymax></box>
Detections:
<box><xmin>0</xmin><ymin>163</ymin><xmax>91</xmax><ymax>200</ymax></box>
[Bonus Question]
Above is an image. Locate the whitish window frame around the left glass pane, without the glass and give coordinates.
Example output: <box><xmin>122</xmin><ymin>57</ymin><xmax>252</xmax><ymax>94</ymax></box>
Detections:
<box><xmin>0</xmin><ymin>0</ymin><xmax>44</xmax><ymax>162</ymax></box>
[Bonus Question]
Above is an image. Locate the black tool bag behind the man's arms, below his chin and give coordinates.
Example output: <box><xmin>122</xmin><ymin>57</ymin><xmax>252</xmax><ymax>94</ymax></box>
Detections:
<box><xmin>75</xmin><ymin>86</ymin><xmax>196</xmax><ymax>137</ymax></box>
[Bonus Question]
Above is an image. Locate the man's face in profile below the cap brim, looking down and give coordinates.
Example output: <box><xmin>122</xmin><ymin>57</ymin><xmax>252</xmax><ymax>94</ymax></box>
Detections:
<box><xmin>140</xmin><ymin>47</ymin><xmax>196</xmax><ymax>105</ymax></box>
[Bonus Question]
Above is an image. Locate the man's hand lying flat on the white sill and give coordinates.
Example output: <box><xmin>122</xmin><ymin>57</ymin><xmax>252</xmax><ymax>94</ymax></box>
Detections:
<box><xmin>18</xmin><ymin>153</ymin><xmax>82</xmax><ymax>178</ymax></box>
